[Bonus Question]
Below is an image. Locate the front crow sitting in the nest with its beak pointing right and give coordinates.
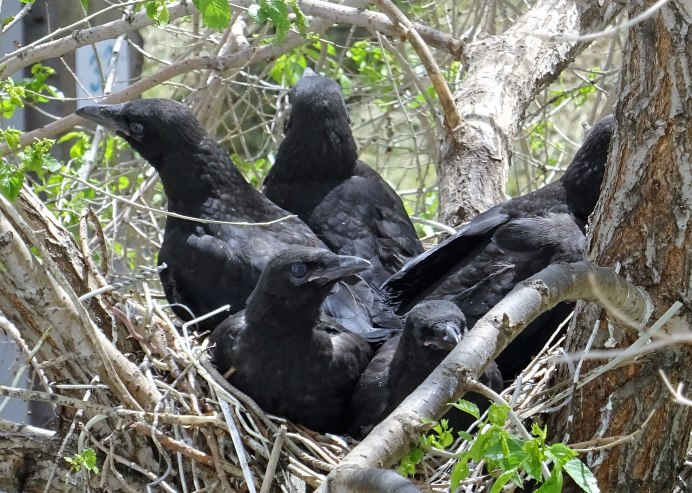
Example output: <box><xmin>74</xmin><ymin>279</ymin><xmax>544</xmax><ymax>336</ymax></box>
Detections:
<box><xmin>211</xmin><ymin>247</ymin><xmax>372</xmax><ymax>433</ymax></box>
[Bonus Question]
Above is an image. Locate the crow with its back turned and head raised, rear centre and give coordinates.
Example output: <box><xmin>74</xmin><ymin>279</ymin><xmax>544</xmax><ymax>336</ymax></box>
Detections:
<box><xmin>264</xmin><ymin>69</ymin><xmax>423</xmax><ymax>286</ymax></box>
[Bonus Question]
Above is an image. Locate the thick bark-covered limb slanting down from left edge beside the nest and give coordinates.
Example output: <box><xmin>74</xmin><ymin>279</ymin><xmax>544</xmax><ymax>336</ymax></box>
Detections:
<box><xmin>0</xmin><ymin>186</ymin><xmax>160</xmax><ymax>409</ymax></box>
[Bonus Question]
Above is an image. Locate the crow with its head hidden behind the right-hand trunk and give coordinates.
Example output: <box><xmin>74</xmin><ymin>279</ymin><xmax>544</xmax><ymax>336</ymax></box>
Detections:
<box><xmin>383</xmin><ymin>116</ymin><xmax>614</xmax><ymax>379</ymax></box>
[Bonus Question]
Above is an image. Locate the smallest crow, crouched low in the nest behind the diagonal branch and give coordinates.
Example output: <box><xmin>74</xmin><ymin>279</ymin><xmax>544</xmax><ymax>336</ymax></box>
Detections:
<box><xmin>349</xmin><ymin>300</ymin><xmax>502</xmax><ymax>438</ymax></box>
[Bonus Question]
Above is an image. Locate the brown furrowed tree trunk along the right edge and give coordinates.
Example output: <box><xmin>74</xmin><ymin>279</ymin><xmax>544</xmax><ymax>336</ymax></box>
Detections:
<box><xmin>549</xmin><ymin>1</ymin><xmax>692</xmax><ymax>492</ymax></box>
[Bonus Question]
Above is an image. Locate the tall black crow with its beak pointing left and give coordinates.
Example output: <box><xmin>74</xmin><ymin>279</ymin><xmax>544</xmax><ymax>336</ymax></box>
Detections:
<box><xmin>77</xmin><ymin>99</ymin><xmax>392</xmax><ymax>332</ymax></box>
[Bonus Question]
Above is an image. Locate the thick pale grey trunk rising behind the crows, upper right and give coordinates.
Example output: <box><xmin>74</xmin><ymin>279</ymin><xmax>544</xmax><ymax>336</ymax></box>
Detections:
<box><xmin>438</xmin><ymin>0</ymin><xmax>622</xmax><ymax>225</ymax></box>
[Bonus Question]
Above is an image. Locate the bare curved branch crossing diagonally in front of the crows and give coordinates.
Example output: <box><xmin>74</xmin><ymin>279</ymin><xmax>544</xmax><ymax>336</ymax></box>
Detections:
<box><xmin>320</xmin><ymin>262</ymin><xmax>651</xmax><ymax>492</ymax></box>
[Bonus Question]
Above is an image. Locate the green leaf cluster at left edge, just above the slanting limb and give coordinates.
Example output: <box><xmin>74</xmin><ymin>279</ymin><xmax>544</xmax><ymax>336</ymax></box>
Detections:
<box><xmin>0</xmin><ymin>132</ymin><xmax>60</xmax><ymax>200</ymax></box>
